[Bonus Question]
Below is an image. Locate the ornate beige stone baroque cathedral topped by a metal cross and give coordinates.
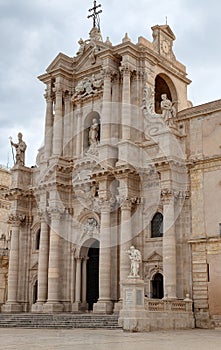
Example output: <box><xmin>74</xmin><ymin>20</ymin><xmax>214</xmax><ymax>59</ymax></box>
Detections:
<box><xmin>1</xmin><ymin>2</ymin><xmax>221</xmax><ymax>329</ymax></box>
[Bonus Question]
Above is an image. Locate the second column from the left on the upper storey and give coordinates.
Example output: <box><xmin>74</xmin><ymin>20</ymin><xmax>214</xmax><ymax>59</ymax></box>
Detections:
<box><xmin>53</xmin><ymin>85</ymin><xmax>63</xmax><ymax>156</ymax></box>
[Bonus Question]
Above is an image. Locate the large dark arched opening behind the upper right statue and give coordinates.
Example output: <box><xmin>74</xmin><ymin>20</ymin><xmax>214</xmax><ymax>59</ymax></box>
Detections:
<box><xmin>155</xmin><ymin>73</ymin><xmax>178</xmax><ymax>114</ymax></box>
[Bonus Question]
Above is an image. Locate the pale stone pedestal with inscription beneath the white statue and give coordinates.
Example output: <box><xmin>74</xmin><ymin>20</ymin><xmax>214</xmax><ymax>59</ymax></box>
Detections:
<box><xmin>118</xmin><ymin>277</ymin><xmax>149</xmax><ymax>332</ymax></box>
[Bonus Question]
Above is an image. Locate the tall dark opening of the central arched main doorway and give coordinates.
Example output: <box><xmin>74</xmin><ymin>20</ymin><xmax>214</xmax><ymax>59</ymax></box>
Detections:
<box><xmin>86</xmin><ymin>240</ymin><xmax>100</xmax><ymax>311</ymax></box>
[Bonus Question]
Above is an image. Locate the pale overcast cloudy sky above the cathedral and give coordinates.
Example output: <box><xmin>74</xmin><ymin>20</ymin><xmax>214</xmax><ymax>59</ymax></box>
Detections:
<box><xmin>0</xmin><ymin>0</ymin><xmax>221</xmax><ymax>167</ymax></box>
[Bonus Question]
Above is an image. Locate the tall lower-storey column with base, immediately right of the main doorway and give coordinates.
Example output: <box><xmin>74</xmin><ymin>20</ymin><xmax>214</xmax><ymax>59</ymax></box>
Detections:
<box><xmin>94</xmin><ymin>201</ymin><xmax>113</xmax><ymax>314</ymax></box>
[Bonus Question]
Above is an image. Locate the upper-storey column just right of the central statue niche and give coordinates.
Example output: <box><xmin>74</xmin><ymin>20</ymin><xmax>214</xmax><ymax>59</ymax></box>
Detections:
<box><xmin>101</xmin><ymin>68</ymin><xmax>112</xmax><ymax>142</ymax></box>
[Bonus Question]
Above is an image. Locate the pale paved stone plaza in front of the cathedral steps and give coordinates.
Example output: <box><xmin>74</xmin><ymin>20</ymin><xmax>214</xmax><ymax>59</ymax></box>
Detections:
<box><xmin>0</xmin><ymin>328</ymin><xmax>221</xmax><ymax>350</ymax></box>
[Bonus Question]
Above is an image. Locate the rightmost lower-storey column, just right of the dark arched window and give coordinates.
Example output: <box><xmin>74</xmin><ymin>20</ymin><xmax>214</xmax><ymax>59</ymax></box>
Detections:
<box><xmin>163</xmin><ymin>191</ymin><xmax>177</xmax><ymax>299</ymax></box>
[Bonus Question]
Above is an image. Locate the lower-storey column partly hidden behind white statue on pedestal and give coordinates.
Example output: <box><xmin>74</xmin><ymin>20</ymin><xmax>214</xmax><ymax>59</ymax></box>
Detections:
<box><xmin>120</xmin><ymin>198</ymin><xmax>132</xmax><ymax>300</ymax></box>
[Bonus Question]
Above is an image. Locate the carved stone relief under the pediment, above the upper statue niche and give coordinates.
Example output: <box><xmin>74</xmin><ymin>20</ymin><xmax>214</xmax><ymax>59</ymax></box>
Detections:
<box><xmin>72</xmin><ymin>74</ymin><xmax>104</xmax><ymax>102</ymax></box>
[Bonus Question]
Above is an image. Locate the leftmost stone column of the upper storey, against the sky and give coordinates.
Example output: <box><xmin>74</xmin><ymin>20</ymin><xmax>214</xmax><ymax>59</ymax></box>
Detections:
<box><xmin>44</xmin><ymin>86</ymin><xmax>53</xmax><ymax>159</ymax></box>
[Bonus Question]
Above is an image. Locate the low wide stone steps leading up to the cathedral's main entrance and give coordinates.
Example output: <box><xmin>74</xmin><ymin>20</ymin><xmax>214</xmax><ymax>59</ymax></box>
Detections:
<box><xmin>0</xmin><ymin>313</ymin><xmax>120</xmax><ymax>329</ymax></box>
